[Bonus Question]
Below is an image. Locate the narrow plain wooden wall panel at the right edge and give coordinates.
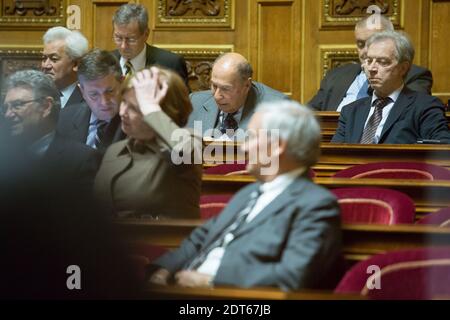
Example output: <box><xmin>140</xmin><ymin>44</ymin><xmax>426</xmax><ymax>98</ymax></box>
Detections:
<box><xmin>429</xmin><ymin>1</ymin><xmax>450</xmax><ymax>103</ymax></box>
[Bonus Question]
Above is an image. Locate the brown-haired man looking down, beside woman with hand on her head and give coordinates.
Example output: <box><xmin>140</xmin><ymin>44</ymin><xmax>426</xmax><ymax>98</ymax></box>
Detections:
<box><xmin>58</xmin><ymin>49</ymin><xmax>125</xmax><ymax>152</ymax></box>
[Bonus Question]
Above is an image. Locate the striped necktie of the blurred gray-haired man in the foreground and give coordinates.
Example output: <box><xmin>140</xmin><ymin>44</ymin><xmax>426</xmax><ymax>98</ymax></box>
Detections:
<box><xmin>186</xmin><ymin>188</ymin><xmax>261</xmax><ymax>270</ymax></box>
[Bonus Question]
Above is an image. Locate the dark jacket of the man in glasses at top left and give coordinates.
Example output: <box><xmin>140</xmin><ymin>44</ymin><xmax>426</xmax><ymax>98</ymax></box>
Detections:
<box><xmin>112</xmin><ymin>44</ymin><xmax>188</xmax><ymax>85</ymax></box>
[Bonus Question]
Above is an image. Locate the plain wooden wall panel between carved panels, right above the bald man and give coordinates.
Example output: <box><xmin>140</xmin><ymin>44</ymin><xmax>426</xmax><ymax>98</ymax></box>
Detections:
<box><xmin>250</xmin><ymin>0</ymin><xmax>301</xmax><ymax>99</ymax></box>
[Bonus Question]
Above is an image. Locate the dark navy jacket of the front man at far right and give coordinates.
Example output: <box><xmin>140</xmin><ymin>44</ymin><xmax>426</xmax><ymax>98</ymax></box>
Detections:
<box><xmin>331</xmin><ymin>87</ymin><xmax>450</xmax><ymax>144</ymax></box>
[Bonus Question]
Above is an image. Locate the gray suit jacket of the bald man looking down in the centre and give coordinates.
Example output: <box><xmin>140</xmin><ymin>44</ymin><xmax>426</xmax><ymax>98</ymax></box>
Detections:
<box><xmin>186</xmin><ymin>81</ymin><xmax>289</xmax><ymax>134</ymax></box>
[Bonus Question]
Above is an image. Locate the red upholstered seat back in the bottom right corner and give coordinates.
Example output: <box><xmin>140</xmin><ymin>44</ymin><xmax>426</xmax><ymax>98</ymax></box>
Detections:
<box><xmin>335</xmin><ymin>247</ymin><xmax>450</xmax><ymax>300</ymax></box>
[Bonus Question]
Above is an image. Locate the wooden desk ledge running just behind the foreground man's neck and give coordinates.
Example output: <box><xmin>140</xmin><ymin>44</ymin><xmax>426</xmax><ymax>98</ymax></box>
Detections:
<box><xmin>202</xmin><ymin>175</ymin><xmax>450</xmax><ymax>219</ymax></box>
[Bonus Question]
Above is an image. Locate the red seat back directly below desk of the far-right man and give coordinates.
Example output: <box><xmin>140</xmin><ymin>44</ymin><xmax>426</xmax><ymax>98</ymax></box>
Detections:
<box><xmin>334</xmin><ymin>162</ymin><xmax>450</xmax><ymax>180</ymax></box>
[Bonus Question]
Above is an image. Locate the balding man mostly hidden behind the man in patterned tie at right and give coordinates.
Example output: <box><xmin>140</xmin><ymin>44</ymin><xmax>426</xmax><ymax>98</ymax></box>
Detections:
<box><xmin>308</xmin><ymin>15</ymin><xmax>433</xmax><ymax>112</ymax></box>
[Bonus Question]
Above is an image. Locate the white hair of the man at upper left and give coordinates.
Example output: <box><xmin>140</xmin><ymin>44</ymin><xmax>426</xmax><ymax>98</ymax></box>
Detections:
<box><xmin>42</xmin><ymin>27</ymin><xmax>89</xmax><ymax>60</ymax></box>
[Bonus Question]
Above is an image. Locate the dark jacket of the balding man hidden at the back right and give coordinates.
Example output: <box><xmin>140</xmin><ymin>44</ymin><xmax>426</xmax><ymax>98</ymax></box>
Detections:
<box><xmin>308</xmin><ymin>63</ymin><xmax>433</xmax><ymax>111</ymax></box>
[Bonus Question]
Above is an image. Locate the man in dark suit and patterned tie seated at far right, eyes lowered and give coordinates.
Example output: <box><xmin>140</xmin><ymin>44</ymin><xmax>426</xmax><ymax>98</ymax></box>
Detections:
<box><xmin>332</xmin><ymin>31</ymin><xmax>450</xmax><ymax>144</ymax></box>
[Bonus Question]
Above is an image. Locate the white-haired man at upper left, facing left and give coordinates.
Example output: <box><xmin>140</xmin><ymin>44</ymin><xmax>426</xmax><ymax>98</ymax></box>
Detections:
<box><xmin>41</xmin><ymin>27</ymin><xmax>88</xmax><ymax>108</ymax></box>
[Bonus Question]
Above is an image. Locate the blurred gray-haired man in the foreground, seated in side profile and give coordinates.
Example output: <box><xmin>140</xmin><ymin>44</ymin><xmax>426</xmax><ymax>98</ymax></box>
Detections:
<box><xmin>149</xmin><ymin>101</ymin><xmax>341</xmax><ymax>290</ymax></box>
